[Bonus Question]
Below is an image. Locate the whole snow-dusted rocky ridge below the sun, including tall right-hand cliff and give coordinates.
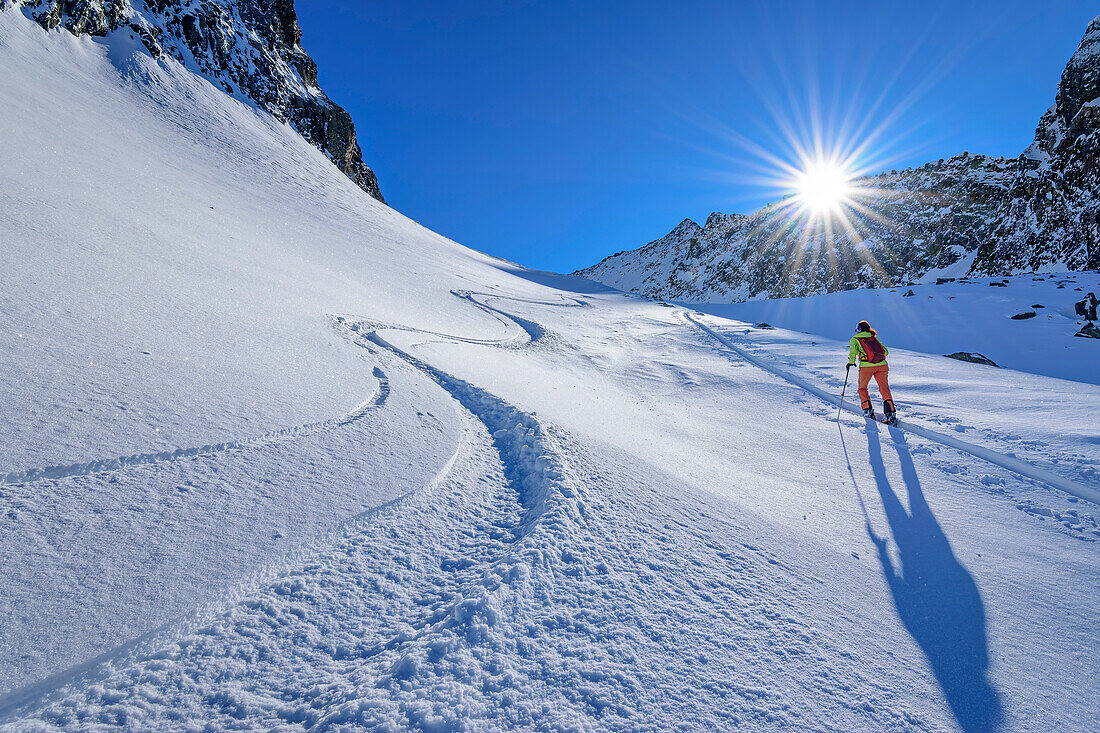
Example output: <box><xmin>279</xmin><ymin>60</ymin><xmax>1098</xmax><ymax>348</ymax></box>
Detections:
<box><xmin>578</xmin><ymin>18</ymin><xmax>1100</xmax><ymax>303</ymax></box>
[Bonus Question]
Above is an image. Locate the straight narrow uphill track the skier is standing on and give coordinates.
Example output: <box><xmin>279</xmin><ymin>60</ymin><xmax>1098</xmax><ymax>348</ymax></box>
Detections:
<box><xmin>681</xmin><ymin>310</ymin><xmax>1100</xmax><ymax>504</ymax></box>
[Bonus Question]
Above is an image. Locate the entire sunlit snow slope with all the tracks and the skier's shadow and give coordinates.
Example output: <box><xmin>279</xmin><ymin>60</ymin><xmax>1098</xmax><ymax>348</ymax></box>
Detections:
<box><xmin>0</xmin><ymin>12</ymin><xmax>1100</xmax><ymax>731</ymax></box>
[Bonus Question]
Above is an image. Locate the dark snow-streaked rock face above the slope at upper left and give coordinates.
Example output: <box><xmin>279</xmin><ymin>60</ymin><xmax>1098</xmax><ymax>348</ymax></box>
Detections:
<box><xmin>22</xmin><ymin>0</ymin><xmax>384</xmax><ymax>201</ymax></box>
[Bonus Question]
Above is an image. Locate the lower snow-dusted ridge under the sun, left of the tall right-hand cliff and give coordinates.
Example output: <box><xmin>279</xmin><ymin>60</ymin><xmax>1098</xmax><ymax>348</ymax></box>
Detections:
<box><xmin>580</xmin><ymin>153</ymin><xmax>1015</xmax><ymax>303</ymax></box>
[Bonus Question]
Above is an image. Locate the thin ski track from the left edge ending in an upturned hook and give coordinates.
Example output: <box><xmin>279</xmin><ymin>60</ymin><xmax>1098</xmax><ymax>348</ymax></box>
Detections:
<box><xmin>0</xmin><ymin>367</ymin><xmax>389</xmax><ymax>485</ymax></box>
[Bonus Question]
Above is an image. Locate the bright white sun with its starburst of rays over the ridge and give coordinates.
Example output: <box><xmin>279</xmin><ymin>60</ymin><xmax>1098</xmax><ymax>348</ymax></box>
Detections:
<box><xmin>655</xmin><ymin>23</ymin><xmax>959</xmax><ymax>297</ymax></box>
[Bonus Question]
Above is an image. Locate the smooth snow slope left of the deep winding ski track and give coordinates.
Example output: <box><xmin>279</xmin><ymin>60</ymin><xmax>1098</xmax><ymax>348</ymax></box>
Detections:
<box><xmin>0</xmin><ymin>11</ymin><xmax>530</xmax><ymax>690</ymax></box>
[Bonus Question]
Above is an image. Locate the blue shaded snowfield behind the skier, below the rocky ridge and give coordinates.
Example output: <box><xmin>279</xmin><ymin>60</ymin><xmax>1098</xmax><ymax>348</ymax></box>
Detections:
<box><xmin>693</xmin><ymin>272</ymin><xmax>1100</xmax><ymax>389</ymax></box>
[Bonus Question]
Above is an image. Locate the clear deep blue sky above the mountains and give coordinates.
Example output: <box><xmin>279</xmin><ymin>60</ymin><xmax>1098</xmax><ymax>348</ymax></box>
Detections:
<box><xmin>296</xmin><ymin>0</ymin><xmax>1100</xmax><ymax>272</ymax></box>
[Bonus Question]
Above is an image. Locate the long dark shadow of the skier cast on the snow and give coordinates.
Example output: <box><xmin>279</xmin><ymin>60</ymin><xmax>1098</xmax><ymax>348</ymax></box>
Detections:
<box><xmin>867</xmin><ymin>425</ymin><xmax>1002</xmax><ymax>733</ymax></box>
